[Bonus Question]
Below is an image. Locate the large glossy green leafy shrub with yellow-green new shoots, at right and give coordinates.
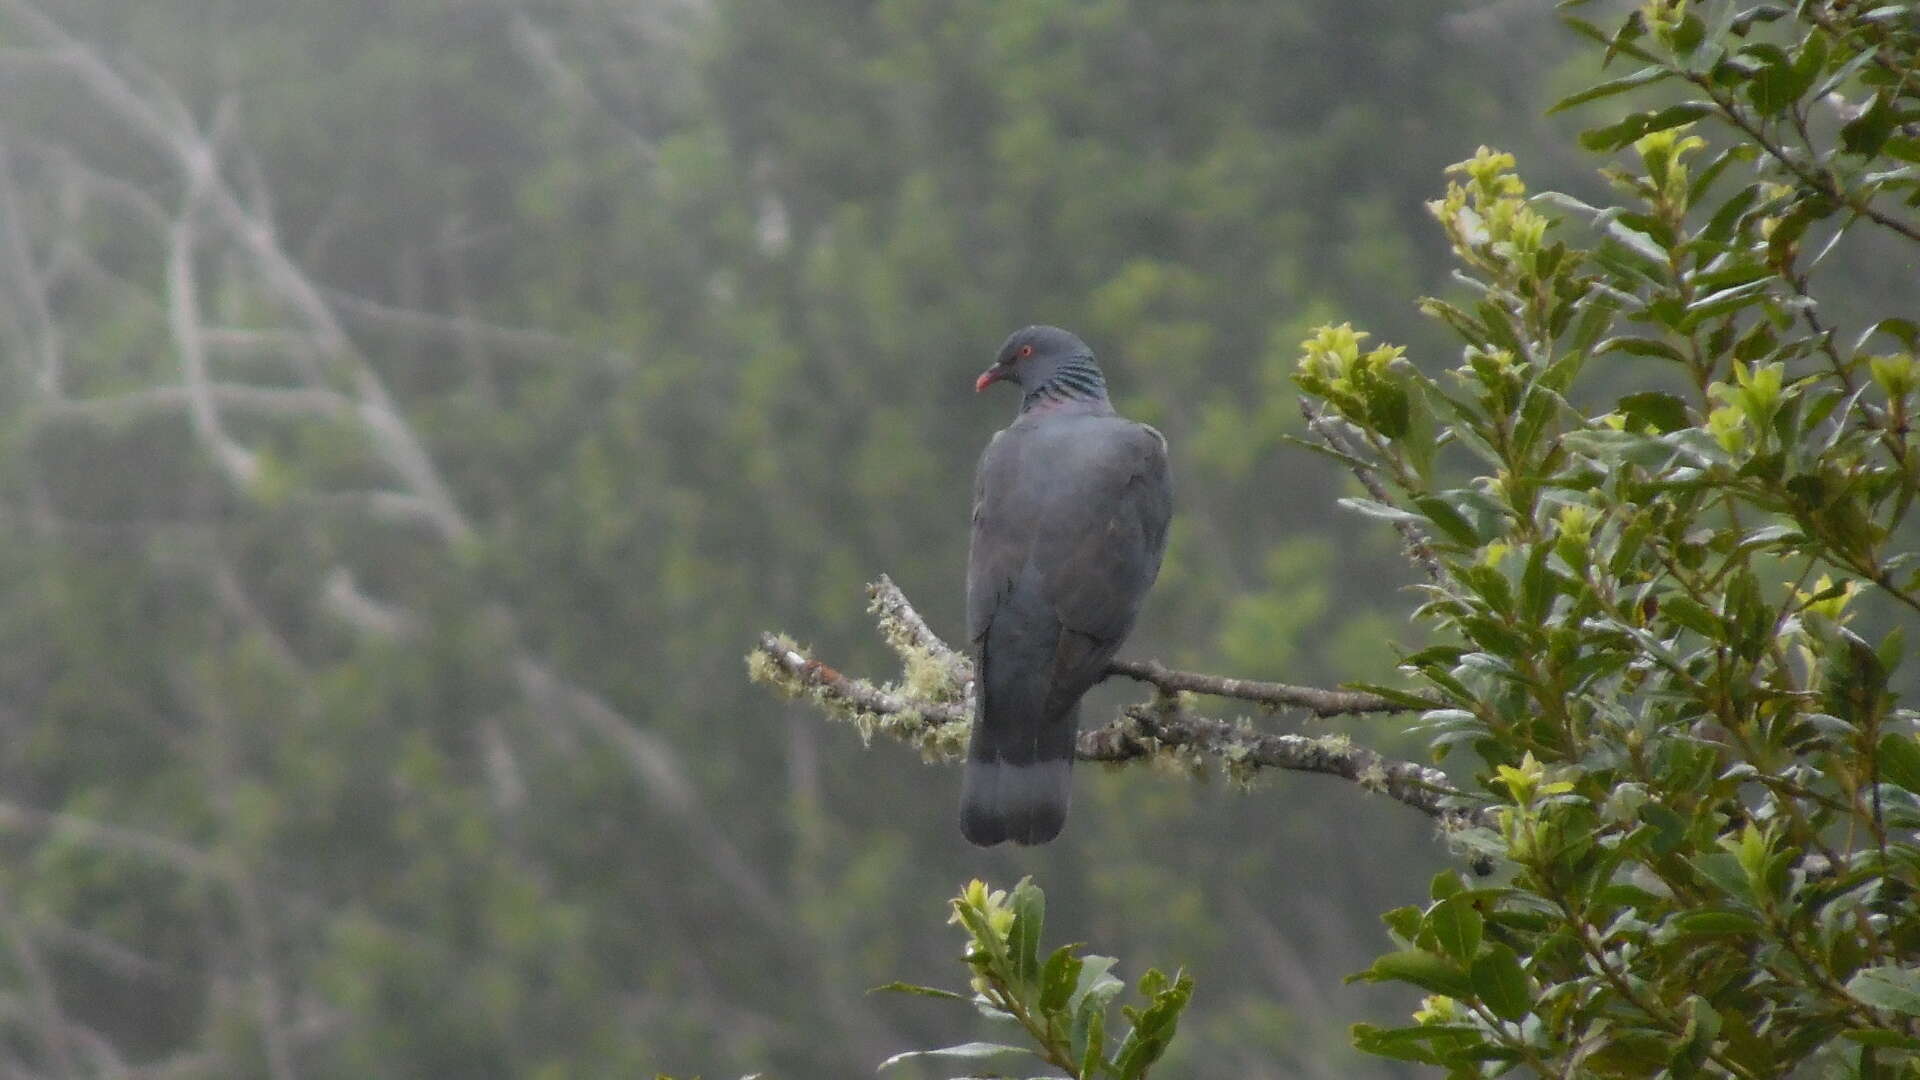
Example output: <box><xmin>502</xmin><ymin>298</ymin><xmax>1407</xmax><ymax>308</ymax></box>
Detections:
<box><xmin>1296</xmin><ymin>0</ymin><xmax>1920</xmax><ymax>1078</ymax></box>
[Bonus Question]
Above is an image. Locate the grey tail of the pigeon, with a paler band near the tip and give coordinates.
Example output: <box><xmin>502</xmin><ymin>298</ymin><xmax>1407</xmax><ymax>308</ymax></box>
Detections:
<box><xmin>960</xmin><ymin>705</ymin><xmax>1079</xmax><ymax>847</ymax></box>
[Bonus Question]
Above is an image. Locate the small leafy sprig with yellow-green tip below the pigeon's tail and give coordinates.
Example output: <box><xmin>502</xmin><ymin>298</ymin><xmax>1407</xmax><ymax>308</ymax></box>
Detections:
<box><xmin>877</xmin><ymin>878</ymin><xmax>1192</xmax><ymax>1080</ymax></box>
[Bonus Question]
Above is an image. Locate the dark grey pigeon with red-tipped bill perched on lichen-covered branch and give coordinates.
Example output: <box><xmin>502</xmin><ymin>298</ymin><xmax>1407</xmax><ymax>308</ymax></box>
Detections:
<box><xmin>960</xmin><ymin>327</ymin><xmax>1173</xmax><ymax>847</ymax></box>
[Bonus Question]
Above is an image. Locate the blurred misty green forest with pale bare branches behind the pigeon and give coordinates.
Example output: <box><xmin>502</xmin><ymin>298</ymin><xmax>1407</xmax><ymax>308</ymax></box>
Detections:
<box><xmin>0</xmin><ymin>0</ymin><xmax>1781</xmax><ymax>1080</ymax></box>
